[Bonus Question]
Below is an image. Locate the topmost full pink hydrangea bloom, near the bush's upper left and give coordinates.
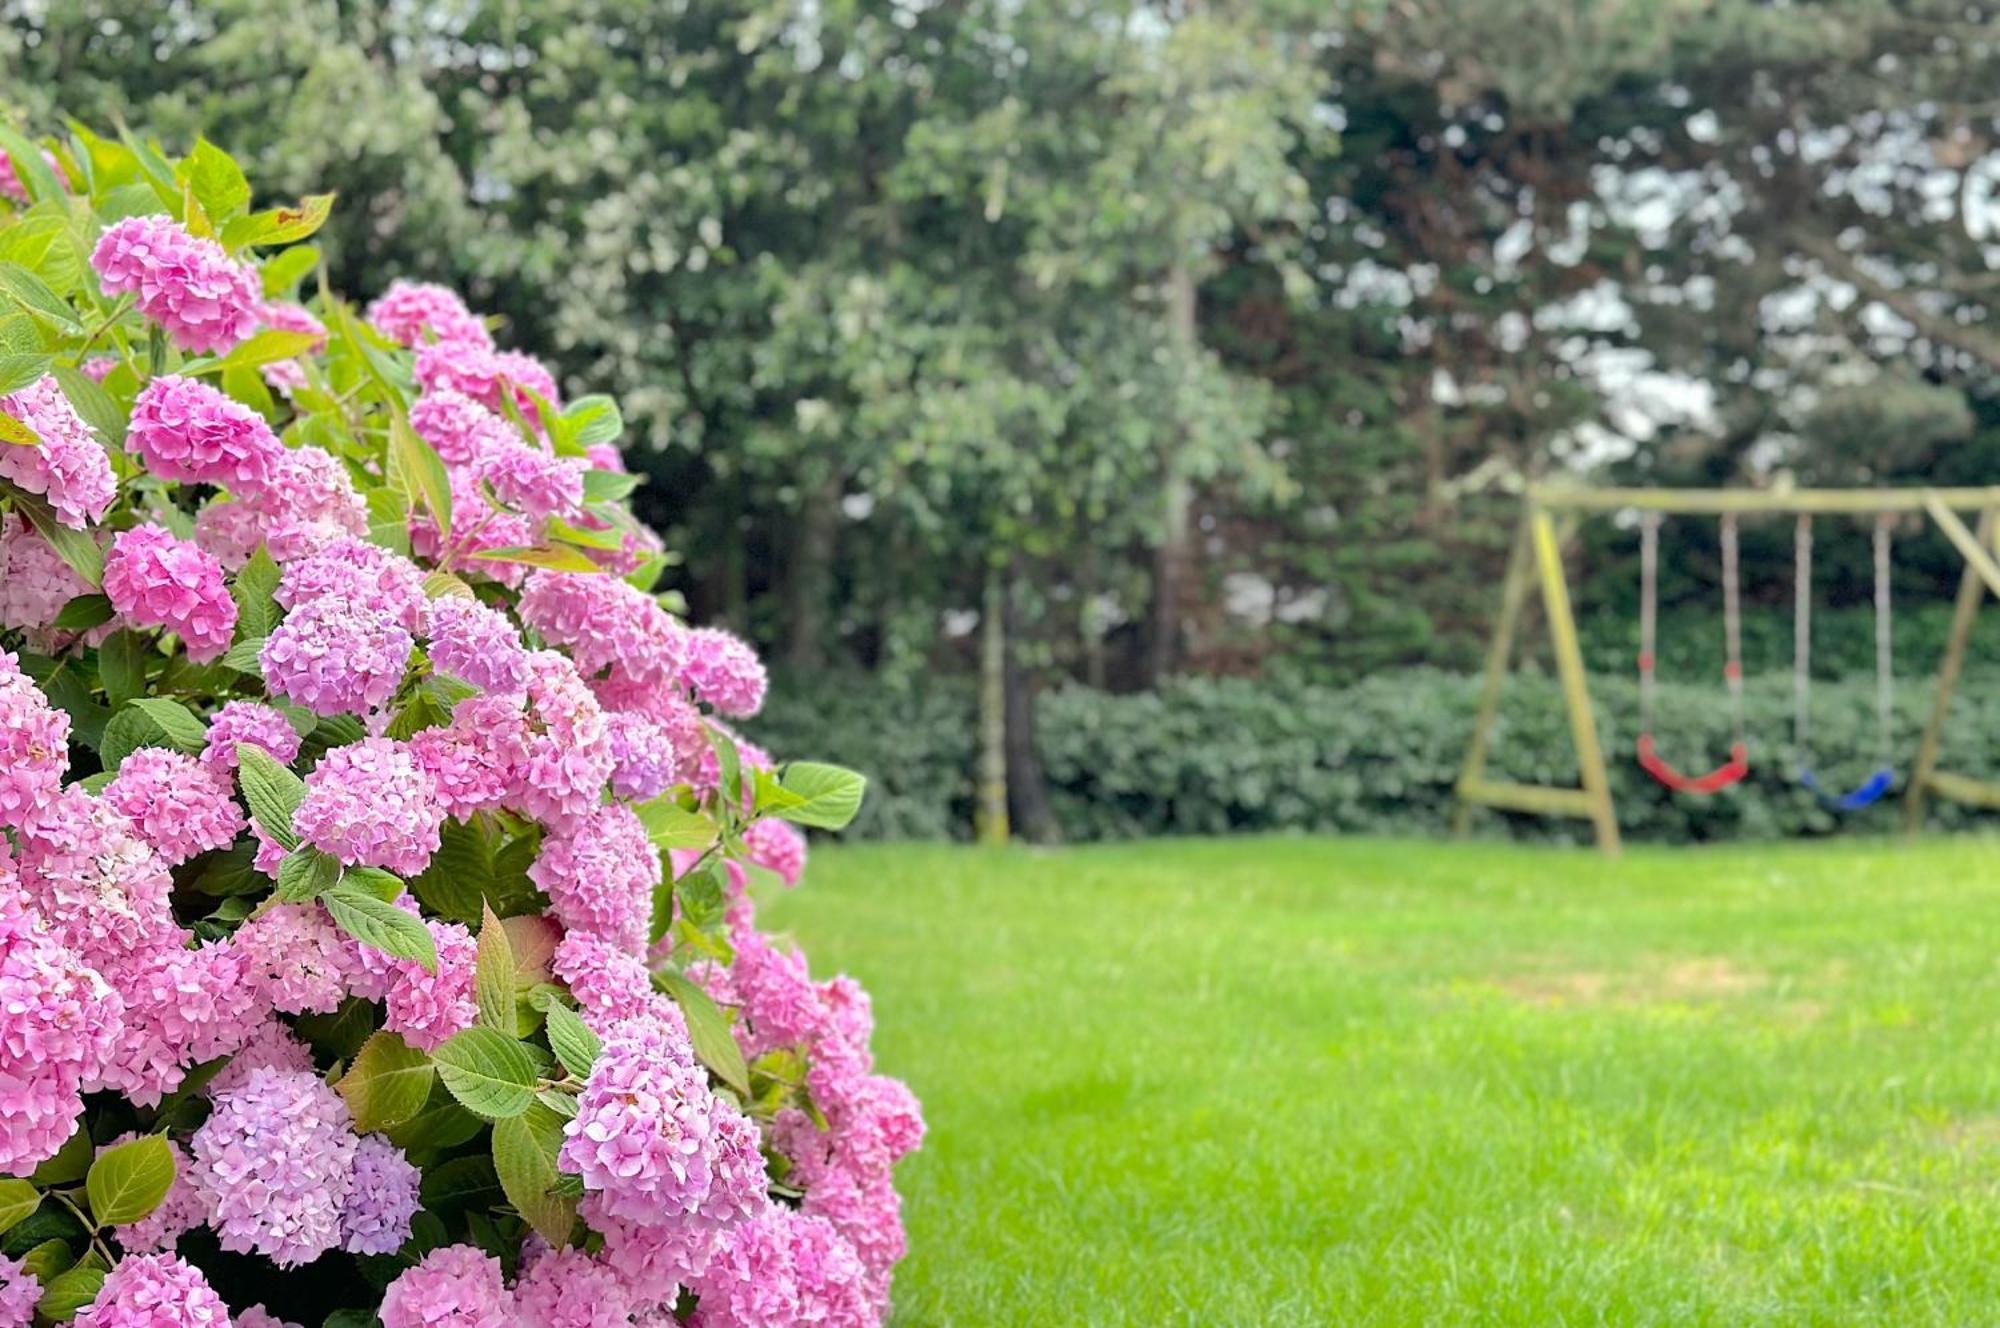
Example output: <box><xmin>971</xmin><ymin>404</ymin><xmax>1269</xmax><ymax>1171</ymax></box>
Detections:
<box><xmin>90</xmin><ymin>216</ymin><xmax>264</xmax><ymax>354</ymax></box>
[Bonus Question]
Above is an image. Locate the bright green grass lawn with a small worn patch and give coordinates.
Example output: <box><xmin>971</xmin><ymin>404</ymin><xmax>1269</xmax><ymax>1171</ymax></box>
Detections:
<box><xmin>764</xmin><ymin>840</ymin><xmax>2000</xmax><ymax>1328</ymax></box>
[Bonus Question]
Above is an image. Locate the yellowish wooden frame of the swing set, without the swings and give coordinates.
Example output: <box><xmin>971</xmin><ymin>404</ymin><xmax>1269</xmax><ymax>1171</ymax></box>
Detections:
<box><xmin>1452</xmin><ymin>484</ymin><xmax>2000</xmax><ymax>854</ymax></box>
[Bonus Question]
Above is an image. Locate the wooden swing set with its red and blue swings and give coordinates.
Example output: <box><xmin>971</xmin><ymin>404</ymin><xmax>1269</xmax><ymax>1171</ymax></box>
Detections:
<box><xmin>1456</xmin><ymin>486</ymin><xmax>2000</xmax><ymax>852</ymax></box>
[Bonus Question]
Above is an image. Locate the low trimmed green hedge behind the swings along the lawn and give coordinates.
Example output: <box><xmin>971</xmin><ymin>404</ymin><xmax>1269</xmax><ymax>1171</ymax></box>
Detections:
<box><xmin>756</xmin><ymin>670</ymin><xmax>2000</xmax><ymax>842</ymax></box>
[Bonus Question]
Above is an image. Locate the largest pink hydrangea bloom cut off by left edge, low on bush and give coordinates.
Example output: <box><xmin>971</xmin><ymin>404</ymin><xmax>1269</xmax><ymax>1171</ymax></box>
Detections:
<box><xmin>0</xmin><ymin>888</ymin><xmax>124</xmax><ymax>1176</ymax></box>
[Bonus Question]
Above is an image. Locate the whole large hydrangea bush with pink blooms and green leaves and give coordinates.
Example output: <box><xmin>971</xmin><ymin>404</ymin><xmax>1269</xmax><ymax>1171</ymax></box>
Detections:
<box><xmin>0</xmin><ymin>130</ymin><xmax>924</xmax><ymax>1328</ymax></box>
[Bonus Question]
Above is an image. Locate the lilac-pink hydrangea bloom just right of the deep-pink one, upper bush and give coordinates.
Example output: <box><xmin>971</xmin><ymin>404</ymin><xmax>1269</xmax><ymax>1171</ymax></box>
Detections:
<box><xmin>258</xmin><ymin>598</ymin><xmax>416</xmax><ymax>714</ymax></box>
